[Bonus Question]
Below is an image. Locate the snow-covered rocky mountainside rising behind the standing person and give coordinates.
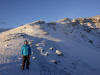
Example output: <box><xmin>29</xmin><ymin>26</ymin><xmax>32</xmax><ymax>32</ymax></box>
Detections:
<box><xmin>0</xmin><ymin>16</ymin><xmax>100</xmax><ymax>75</ymax></box>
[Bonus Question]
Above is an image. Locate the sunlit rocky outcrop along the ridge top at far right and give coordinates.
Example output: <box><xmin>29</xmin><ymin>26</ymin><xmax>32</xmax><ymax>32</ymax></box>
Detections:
<box><xmin>72</xmin><ymin>16</ymin><xmax>100</xmax><ymax>29</ymax></box>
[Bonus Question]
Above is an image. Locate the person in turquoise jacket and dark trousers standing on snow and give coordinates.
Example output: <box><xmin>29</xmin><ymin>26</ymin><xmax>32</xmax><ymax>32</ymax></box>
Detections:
<box><xmin>21</xmin><ymin>40</ymin><xmax>31</xmax><ymax>70</ymax></box>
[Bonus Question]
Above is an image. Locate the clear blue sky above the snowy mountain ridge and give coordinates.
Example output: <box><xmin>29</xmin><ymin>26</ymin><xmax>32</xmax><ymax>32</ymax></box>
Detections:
<box><xmin>0</xmin><ymin>0</ymin><xmax>100</xmax><ymax>28</ymax></box>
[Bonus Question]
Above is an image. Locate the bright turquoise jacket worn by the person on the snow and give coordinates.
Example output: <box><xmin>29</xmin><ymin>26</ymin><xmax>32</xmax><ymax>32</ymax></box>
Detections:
<box><xmin>21</xmin><ymin>44</ymin><xmax>31</xmax><ymax>56</ymax></box>
